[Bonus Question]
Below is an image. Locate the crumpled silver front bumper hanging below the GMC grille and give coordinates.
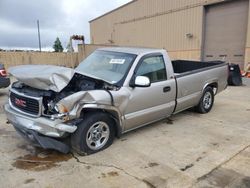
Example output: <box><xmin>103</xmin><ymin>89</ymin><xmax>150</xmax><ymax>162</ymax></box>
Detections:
<box><xmin>4</xmin><ymin>104</ymin><xmax>77</xmax><ymax>153</ymax></box>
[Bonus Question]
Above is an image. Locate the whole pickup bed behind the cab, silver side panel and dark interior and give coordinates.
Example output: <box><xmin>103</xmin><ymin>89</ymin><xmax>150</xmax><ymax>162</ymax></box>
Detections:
<box><xmin>172</xmin><ymin>60</ymin><xmax>228</xmax><ymax>113</ymax></box>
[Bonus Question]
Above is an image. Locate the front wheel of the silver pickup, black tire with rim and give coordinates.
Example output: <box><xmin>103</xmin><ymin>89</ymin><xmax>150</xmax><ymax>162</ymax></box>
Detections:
<box><xmin>71</xmin><ymin>112</ymin><xmax>115</xmax><ymax>155</ymax></box>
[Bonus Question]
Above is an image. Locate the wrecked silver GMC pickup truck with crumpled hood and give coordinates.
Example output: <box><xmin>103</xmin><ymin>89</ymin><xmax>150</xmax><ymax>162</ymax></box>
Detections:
<box><xmin>5</xmin><ymin>47</ymin><xmax>228</xmax><ymax>155</ymax></box>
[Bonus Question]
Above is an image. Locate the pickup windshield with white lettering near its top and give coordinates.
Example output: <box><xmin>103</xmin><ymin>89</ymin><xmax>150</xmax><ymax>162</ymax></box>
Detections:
<box><xmin>76</xmin><ymin>50</ymin><xmax>136</xmax><ymax>84</ymax></box>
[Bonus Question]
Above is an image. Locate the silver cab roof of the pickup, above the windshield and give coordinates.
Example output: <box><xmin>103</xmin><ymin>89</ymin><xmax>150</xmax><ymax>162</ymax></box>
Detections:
<box><xmin>97</xmin><ymin>47</ymin><xmax>163</xmax><ymax>55</ymax></box>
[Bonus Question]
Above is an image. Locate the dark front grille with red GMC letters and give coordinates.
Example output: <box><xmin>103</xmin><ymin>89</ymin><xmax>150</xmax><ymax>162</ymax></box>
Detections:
<box><xmin>10</xmin><ymin>92</ymin><xmax>40</xmax><ymax>116</ymax></box>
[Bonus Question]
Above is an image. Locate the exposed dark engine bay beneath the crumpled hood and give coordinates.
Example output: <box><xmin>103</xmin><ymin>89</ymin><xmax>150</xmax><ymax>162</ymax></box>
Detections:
<box><xmin>12</xmin><ymin>73</ymin><xmax>119</xmax><ymax>115</ymax></box>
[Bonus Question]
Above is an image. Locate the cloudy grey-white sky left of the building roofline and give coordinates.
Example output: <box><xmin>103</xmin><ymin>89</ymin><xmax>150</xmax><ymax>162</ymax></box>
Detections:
<box><xmin>0</xmin><ymin>0</ymin><xmax>131</xmax><ymax>49</ymax></box>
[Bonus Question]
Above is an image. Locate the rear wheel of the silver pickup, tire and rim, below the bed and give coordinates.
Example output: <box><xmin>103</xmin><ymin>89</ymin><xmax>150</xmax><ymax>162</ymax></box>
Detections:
<box><xmin>195</xmin><ymin>87</ymin><xmax>214</xmax><ymax>114</ymax></box>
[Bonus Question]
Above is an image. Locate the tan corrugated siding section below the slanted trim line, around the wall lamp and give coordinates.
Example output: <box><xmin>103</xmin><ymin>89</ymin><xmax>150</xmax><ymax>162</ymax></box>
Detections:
<box><xmin>114</xmin><ymin>7</ymin><xmax>203</xmax><ymax>51</ymax></box>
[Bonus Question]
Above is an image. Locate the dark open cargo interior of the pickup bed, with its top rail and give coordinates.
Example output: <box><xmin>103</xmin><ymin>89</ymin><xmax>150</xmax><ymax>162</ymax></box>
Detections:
<box><xmin>172</xmin><ymin>60</ymin><xmax>225</xmax><ymax>77</ymax></box>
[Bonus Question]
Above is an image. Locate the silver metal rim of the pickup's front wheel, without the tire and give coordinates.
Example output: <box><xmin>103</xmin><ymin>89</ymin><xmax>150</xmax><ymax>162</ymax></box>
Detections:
<box><xmin>86</xmin><ymin>121</ymin><xmax>110</xmax><ymax>150</ymax></box>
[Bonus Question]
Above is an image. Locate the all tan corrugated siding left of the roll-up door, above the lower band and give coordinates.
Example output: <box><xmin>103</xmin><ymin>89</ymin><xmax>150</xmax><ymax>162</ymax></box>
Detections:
<box><xmin>90</xmin><ymin>0</ymin><xmax>227</xmax><ymax>50</ymax></box>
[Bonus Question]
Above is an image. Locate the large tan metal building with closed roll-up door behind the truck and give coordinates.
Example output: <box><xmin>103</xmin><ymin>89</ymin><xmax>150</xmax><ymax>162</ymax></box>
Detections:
<box><xmin>90</xmin><ymin>0</ymin><xmax>250</xmax><ymax>69</ymax></box>
